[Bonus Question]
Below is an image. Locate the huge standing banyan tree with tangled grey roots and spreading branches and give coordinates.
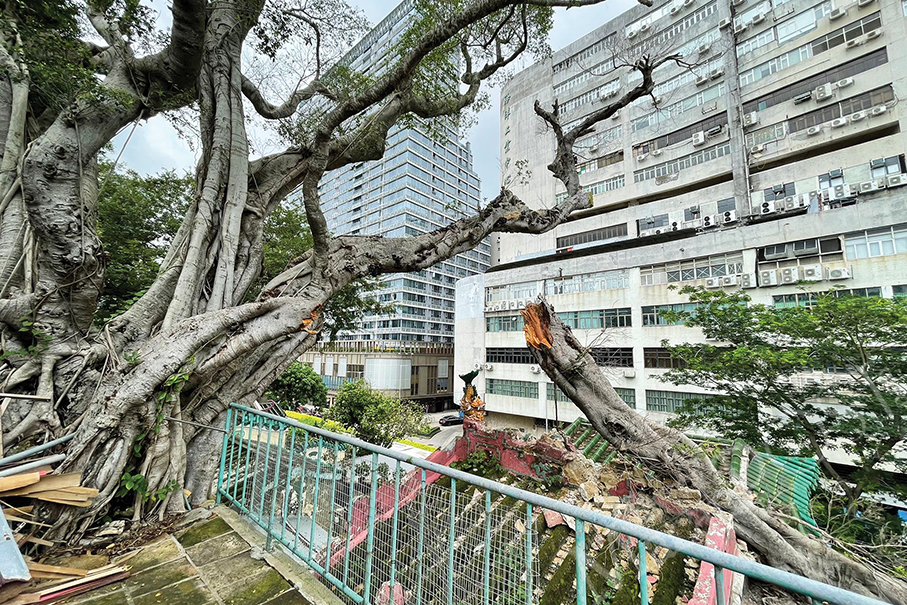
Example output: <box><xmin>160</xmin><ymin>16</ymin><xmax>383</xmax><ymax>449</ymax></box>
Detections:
<box><xmin>0</xmin><ymin>0</ymin><xmax>668</xmax><ymax>536</ymax></box>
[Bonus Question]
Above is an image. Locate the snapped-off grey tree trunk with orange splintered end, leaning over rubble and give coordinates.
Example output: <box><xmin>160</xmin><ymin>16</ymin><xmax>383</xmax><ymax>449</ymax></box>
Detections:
<box><xmin>522</xmin><ymin>300</ymin><xmax>907</xmax><ymax>604</ymax></box>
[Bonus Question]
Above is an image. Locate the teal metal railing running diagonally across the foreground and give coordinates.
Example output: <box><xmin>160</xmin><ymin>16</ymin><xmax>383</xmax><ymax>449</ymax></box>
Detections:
<box><xmin>217</xmin><ymin>405</ymin><xmax>882</xmax><ymax>605</ymax></box>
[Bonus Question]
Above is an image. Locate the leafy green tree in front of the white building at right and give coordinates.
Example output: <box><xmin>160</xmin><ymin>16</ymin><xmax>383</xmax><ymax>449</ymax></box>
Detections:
<box><xmin>664</xmin><ymin>288</ymin><xmax>907</xmax><ymax>501</ymax></box>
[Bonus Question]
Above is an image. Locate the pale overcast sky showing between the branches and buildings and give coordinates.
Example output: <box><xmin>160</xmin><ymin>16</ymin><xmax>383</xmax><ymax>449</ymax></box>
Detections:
<box><xmin>113</xmin><ymin>0</ymin><xmax>636</xmax><ymax>203</ymax></box>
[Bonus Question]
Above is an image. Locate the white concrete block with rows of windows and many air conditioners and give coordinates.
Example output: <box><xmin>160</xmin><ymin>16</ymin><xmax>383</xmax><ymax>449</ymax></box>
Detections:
<box><xmin>454</xmin><ymin>0</ymin><xmax>907</xmax><ymax>438</ymax></box>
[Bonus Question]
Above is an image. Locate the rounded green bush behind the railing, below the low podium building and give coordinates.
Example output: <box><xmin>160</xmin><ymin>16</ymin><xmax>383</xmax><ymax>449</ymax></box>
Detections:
<box><xmin>326</xmin><ymin>380</ymin><xmax>425</xmax><ymax>447</ymax></box>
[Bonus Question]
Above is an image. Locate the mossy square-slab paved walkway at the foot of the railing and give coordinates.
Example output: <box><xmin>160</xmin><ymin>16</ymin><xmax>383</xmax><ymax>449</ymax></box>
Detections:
<box><xmin>65</xmin><ymin>507</ymin><xmax>340</xmax><ymax>605</ymax></box>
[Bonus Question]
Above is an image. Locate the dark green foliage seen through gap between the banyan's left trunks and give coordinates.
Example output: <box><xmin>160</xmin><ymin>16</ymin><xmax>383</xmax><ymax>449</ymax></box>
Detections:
<box><xmin>95</xmin><ymin>162</ymin><xmax>195</xmax><ymax>323</ymax></box>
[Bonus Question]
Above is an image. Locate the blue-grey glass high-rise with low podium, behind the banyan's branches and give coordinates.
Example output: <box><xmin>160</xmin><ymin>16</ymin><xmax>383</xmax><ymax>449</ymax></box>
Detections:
<box><xmin>303</xmin><ymin>0</ymin><xmax>490</xmax><ymax>409</ymax></box>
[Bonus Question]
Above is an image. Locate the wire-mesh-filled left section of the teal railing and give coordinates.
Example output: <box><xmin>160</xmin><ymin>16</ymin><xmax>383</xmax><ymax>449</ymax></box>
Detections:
<box><xmin>219</xmin><ymin>411</ymin><xmax>538</xmax><ymax>605</ymax></box>
